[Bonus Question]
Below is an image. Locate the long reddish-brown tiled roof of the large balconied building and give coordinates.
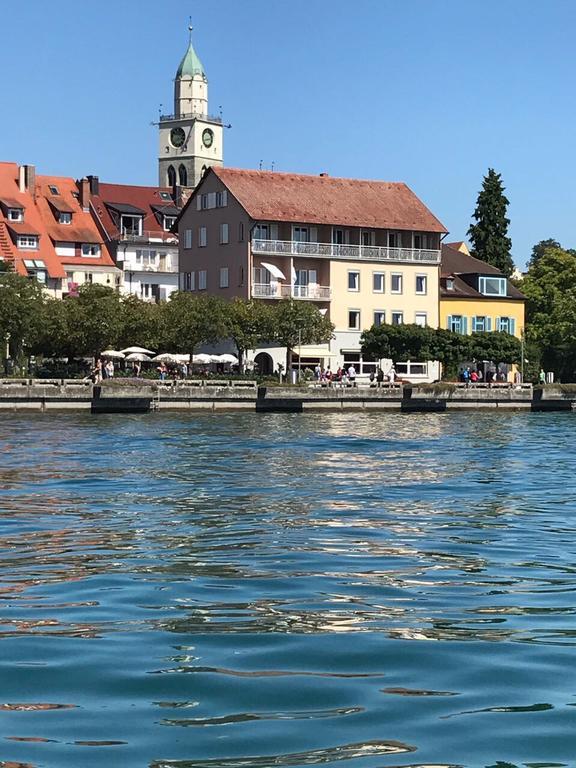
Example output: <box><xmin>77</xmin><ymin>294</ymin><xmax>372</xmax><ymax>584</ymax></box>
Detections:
<box><xmin>205</xmin><ymin>167</ymin><xmax>447</xmax><ymax>233</ymax></box>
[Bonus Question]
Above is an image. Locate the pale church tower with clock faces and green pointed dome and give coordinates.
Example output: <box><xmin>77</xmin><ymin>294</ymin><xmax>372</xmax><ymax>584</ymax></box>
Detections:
<box><xmin>158</xmin><ymin>27</ymin><xmax>223</xmax><ymax>190</ymax></box>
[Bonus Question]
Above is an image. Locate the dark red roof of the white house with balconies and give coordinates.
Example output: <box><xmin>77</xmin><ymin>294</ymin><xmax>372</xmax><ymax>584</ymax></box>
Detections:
<box><xmin>92</xmin><ymin>182</ymin><xmax>180</xmax><ymax>240</ymax></box>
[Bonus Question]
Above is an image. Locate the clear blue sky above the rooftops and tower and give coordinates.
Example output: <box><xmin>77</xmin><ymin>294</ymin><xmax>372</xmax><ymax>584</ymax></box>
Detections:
<box><xmin>0</xmin><ymin>0</ymin><xmax>576</xmax><ymax>266</ymax></box>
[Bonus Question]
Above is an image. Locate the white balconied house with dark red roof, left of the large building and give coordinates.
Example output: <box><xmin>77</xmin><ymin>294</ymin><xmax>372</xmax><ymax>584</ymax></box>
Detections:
<box><xmin>88</xmin><ymin>176</ymin><xmax>180</xmax><ymax>301</ymax></box>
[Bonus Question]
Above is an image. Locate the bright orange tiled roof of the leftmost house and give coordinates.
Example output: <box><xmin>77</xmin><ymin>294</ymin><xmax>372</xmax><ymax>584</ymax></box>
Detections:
<box><xmin>0</xmin><ymin>163</ymin><xmax>66</xmax><ymax>278</ymax></box>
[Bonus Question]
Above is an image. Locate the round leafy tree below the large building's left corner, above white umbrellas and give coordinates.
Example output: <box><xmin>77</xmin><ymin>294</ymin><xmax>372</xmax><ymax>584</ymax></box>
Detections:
<box><xmin>160</xmin><ymin>291</ymin><xmax>228</xmax><ymax>359</ymax></box>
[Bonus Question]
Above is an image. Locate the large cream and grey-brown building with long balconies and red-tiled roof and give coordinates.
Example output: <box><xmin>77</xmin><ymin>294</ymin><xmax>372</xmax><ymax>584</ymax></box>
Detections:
<box><xmin>178</xmin><ymin>167</ymin><xmax>447</xmax><ymax>381</ymax></box>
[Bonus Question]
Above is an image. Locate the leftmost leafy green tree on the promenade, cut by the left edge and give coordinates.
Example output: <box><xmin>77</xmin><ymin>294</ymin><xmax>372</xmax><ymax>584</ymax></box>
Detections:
<box><xmin>0</xmin><ymin>271</ymin><xmax>44</xmax><ymax>358</ymax></box>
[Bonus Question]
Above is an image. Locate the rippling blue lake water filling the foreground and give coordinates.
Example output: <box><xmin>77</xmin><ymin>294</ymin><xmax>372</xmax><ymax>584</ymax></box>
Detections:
<box><xmin>0</xmin><ymin>413</ymin><xmax>576</xmax><ymax>768</ymax></box>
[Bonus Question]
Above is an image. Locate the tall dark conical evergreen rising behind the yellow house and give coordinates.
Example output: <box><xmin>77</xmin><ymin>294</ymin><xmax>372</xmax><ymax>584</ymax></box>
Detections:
<box><xmin>468</xmin><ymin>168</ymin><xmax>514</xmax><ymax>277</ymax></box>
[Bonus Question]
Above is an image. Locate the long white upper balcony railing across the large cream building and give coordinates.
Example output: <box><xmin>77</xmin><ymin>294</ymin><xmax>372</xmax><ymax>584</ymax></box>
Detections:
<box><xmin>252</xmin><ymin>239</ymin><xmax>440</xmax><ymax>264</ymax></box>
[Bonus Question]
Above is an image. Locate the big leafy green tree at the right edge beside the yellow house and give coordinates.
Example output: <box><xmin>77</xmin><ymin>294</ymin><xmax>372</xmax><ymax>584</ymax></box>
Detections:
<box><xmin>522</xmin><ymin>247</ymin><xmax>576</xmax><ymax>381</ymax></box>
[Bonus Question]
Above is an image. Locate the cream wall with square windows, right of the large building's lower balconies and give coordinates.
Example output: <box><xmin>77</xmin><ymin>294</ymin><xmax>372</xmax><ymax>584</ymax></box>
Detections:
<box><xmin>330</xmin><ymin>260</ymin><xmax>439</xmax><ymax>331</ymax></box>
